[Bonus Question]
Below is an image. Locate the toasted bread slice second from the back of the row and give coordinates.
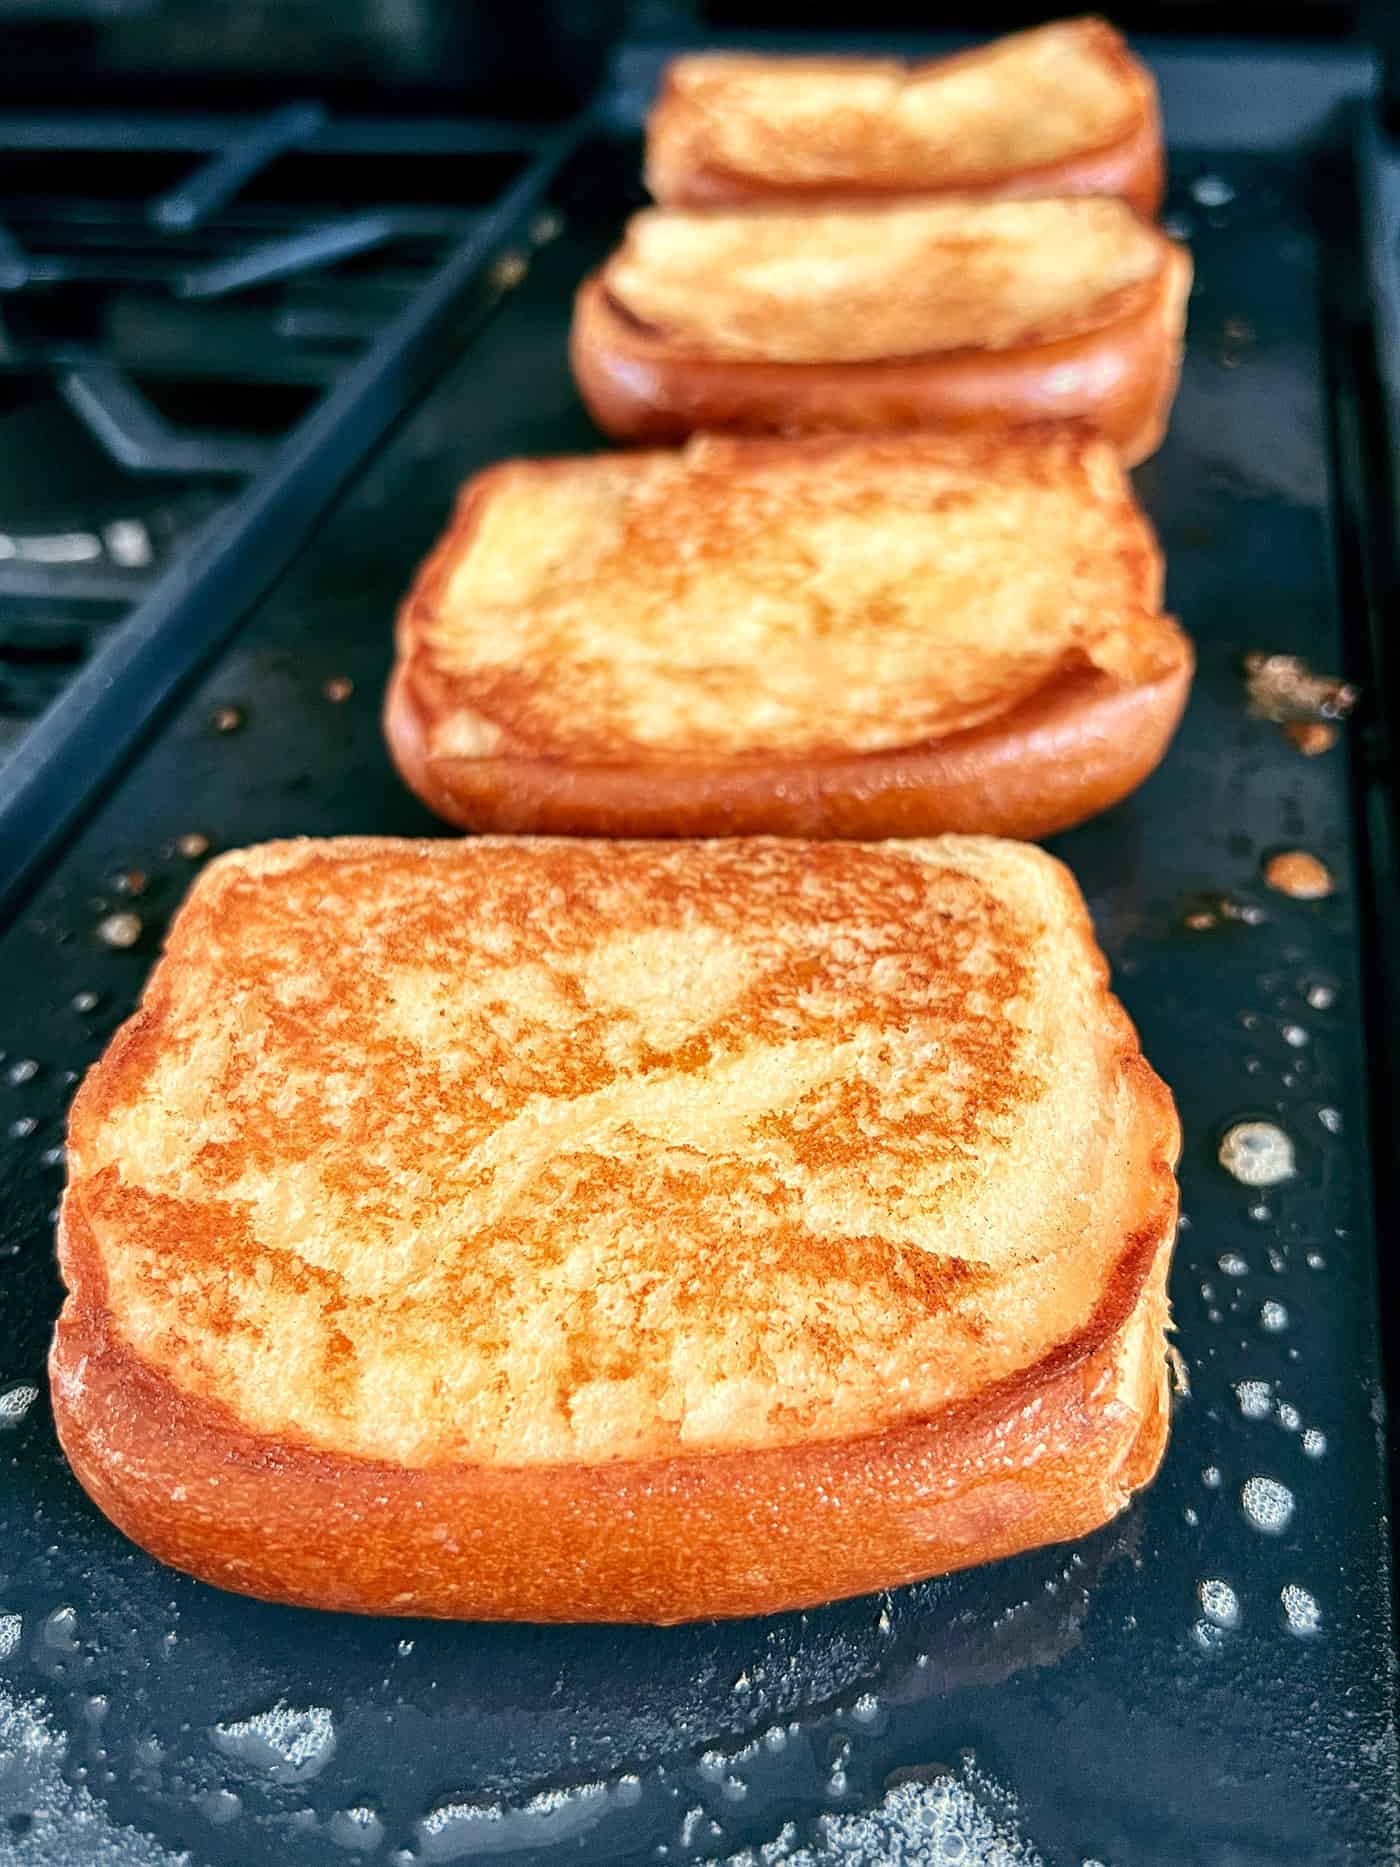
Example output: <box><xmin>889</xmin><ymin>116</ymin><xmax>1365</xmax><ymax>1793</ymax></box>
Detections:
<box><xmin>569</xmin><ymin>196</ymin><xmax>1191</xmax><ymax>465</ymax></box>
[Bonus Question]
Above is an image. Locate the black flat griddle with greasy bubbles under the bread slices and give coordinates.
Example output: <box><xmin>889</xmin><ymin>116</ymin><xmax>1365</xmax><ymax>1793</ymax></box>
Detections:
<box><xmin>0</xmin><ymin>32</ymin><xmax>1400</xmax><ymax>1867</ymax></box>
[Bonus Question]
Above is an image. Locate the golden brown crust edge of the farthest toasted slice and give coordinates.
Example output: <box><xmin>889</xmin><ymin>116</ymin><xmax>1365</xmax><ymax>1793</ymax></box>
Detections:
<box><xmin>646</xmin><ymin>17</ymin><xmax>1167</xmax><ymax>218</ymax></box>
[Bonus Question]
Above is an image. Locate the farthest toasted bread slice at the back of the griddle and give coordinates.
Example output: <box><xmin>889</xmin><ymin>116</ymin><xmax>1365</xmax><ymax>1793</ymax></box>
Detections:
<box><xmin>646</xmin><ymin>19</ymin><xmax>1165</xmax><ymax>215</ymax></box>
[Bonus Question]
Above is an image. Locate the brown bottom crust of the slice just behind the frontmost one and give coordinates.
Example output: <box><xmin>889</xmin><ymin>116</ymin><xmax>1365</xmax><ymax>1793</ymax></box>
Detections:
<box><xmin>385</xmin><ymin>633</ymin><xmax>1195</xmax><ymax>840</ymax></box>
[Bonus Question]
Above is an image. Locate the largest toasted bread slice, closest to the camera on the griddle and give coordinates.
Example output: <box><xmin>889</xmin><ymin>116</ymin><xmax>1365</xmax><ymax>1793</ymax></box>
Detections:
<box><xmin>52</xmin><ymin>838</ymin><xmax>1178</xmax><ymax>1621</ymax></box>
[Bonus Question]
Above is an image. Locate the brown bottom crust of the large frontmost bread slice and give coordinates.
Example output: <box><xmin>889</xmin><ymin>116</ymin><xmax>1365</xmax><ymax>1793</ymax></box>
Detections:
<box><xmin>50</xmin><ymin>1075</ymin><xmax>1178</xmax><ymax>1624</ymax></box>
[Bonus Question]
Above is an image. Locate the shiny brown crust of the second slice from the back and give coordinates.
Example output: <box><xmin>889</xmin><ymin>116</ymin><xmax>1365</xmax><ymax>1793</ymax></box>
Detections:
<box><xmin>569</xmin><ymin>237</ymin><xmax>1191</xmax><ymax>467</ymax></box>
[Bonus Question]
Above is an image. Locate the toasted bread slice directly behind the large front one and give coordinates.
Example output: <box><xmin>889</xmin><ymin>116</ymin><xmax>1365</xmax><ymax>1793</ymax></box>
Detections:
<box><xmin>386</xmin><ymin>428</ymin><xmax>1191</xmax><ymax>838</ymax></box>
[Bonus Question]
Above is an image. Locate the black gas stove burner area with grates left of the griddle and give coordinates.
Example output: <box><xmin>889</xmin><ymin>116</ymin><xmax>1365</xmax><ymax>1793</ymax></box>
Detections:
<box><xmin>0</xmin><ymin>101</ymin><xmax>552</xmax><ymax>758</ymax></box>
